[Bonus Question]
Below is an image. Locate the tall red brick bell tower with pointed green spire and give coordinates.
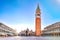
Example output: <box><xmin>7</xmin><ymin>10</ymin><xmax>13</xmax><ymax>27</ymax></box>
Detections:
<box><xmin>35</xmin><ymin>4</ymin><xmax>41</xmax><ymax>36</ymax></box>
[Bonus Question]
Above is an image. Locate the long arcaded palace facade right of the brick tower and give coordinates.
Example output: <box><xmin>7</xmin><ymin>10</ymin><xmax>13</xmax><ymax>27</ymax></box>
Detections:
<box><xmin>42</xmin><ymin>22</ymin><xmax>60</xmax><ymax>36</ymax></box>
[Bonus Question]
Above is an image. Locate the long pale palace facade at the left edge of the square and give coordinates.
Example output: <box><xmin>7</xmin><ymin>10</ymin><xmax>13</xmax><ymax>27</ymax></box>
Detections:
<box><xmin>0</xmin><ymin>23</ymin><xmax>17</xmax><ymax>36</ymax></box>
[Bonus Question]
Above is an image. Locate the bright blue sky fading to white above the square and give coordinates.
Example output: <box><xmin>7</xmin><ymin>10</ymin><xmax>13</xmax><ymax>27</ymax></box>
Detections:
<box><xmin>0</xmin><ymin>0</ymin><xmax>60</xmax><ymax>32</ymax></box>
